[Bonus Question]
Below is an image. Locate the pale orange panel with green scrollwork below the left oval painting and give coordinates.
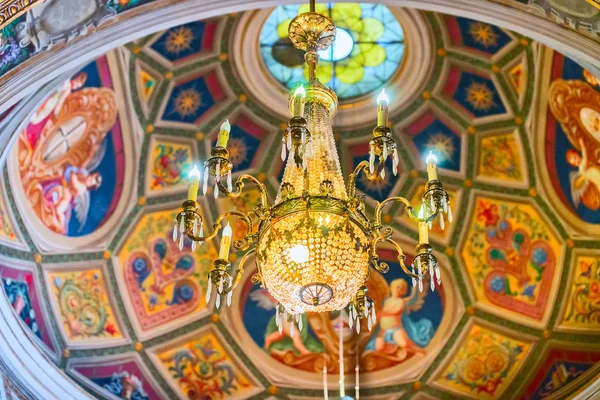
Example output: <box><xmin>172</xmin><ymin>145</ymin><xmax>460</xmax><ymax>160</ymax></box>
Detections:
<box><xmin>48</xmin><ymin>268</ymin><xmax>123</xmax><ymax>341</ymax></box>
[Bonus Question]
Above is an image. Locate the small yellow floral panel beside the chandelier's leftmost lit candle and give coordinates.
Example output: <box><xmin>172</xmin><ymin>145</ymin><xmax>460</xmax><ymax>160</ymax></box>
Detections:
<box><xmin>150</xmin><ymin>142</ymin><xmax>192</xmax><ymax>192</ymax></box>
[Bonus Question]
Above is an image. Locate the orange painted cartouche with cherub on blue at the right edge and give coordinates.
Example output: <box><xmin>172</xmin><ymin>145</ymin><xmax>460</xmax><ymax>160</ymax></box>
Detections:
<box><xmin>549</xmin><ymin>79</ymin><xmax>600</xmax><ymax>211</ymax></box>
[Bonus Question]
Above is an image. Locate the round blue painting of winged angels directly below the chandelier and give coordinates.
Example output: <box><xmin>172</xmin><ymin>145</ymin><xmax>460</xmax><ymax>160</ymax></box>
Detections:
<box><xmin>242</xmin><ymin>262</ymin><xmax>443</xmax><ymax>373</ymax></box>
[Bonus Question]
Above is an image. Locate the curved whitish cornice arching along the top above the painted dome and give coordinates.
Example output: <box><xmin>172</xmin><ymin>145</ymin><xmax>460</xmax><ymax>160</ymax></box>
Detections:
<box><xmin>0</xmin><ymin>0</ymin><xmax>600</xmax><ymax>112</ymax></box>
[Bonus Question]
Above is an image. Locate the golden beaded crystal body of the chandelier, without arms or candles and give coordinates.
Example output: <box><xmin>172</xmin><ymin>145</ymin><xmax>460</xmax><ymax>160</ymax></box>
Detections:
<box><xmin>257</xmin><ymin>88</ymin><xmax>372</xmax><ymax>314</ymax></box>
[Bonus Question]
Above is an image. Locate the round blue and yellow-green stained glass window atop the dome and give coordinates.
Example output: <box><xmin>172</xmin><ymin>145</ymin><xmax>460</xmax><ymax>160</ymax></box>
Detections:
<box><xmin>259</xmin><ymin>3</ymin><xmax>404</xmax><ymax>100</ymax></box>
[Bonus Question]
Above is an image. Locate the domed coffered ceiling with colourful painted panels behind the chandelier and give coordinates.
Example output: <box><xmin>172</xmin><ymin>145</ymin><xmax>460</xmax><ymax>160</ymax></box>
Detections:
<box><xmin>0</xmin><ymin>4</ymin><xmax>600</xmax><ymax>399</ymax></box>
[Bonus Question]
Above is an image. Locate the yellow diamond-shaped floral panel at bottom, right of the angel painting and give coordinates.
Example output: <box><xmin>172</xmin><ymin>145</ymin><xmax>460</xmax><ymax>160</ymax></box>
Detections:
<box><xmin>436</xmin><ymin>325</ymin><xmax>530</xmax><ymax>399</ymax></box>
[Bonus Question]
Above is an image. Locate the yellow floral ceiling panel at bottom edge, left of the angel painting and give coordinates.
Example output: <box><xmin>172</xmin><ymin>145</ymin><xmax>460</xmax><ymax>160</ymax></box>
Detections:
<box><xmin>158</xmin><ymin>332</ymin><xmax>254</xmax><ymax>400</ymax></box>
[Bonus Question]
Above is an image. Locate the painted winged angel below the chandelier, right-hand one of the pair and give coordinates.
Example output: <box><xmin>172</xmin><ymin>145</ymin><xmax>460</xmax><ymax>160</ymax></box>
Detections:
<box><xmin>366</xmin><ymin>279</ymin><xmax>434</xmax><ymax>357</ymax></box>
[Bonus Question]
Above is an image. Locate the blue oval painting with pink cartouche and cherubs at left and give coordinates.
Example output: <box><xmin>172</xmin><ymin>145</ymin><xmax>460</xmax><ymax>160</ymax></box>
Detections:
<box><xmin>18</xmin><ymin>57</ymin><xmax>117</xmax><ymax>236</ymax></box>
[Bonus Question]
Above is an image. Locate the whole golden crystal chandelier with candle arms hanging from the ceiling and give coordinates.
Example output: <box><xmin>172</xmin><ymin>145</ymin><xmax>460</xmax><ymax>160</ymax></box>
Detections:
<box><xmin>173</xmin><ymin>0</ymin><xmax>452</xmax><ymax>335</ymax></box>
